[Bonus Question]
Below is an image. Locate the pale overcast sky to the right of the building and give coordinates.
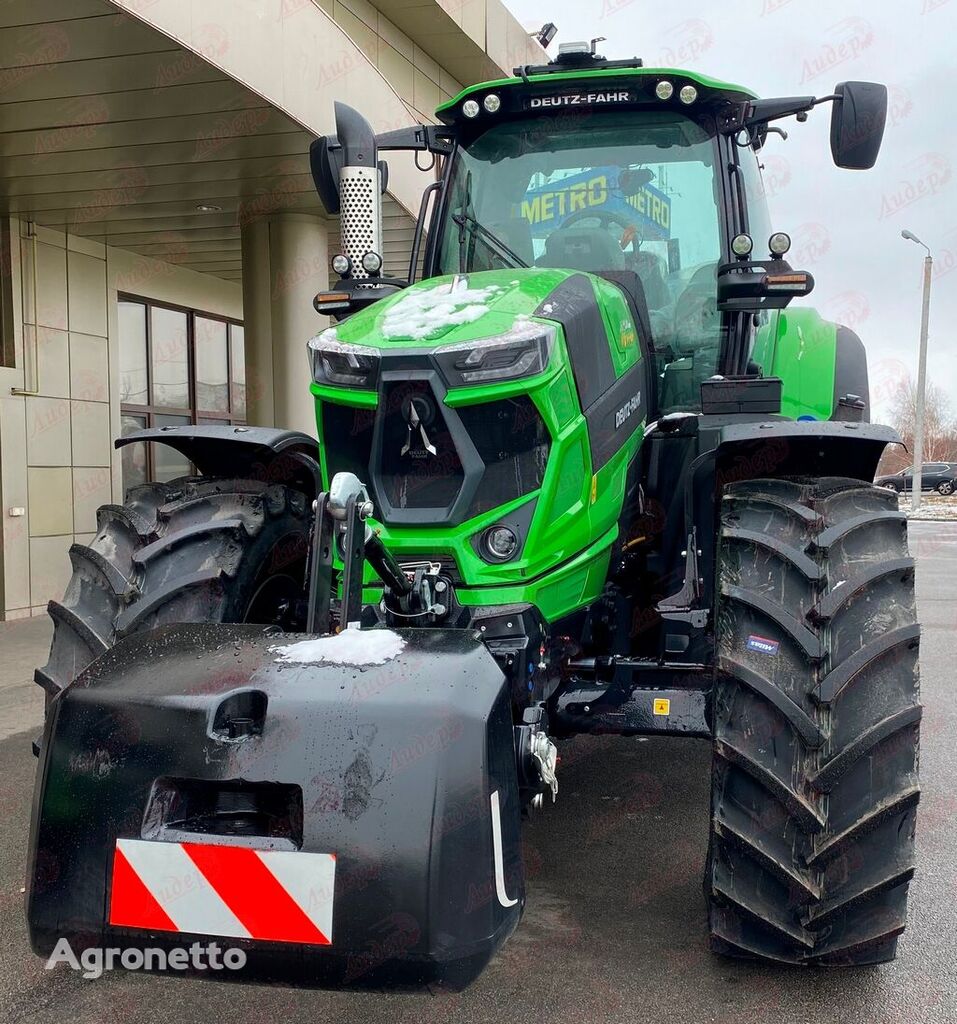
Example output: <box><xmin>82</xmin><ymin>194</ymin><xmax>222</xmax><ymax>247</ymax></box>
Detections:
<box><xmin>506</xmin><ymin>0</ymin><xmax>957</xmax><ymax>420</ymax></box>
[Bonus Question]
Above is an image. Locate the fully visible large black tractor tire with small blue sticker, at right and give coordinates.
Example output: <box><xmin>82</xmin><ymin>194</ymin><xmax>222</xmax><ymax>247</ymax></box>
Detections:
<box><xmin>705</xmin><ymin>478</ymin><xmax>921</xmax><ymax>965</ymax></box>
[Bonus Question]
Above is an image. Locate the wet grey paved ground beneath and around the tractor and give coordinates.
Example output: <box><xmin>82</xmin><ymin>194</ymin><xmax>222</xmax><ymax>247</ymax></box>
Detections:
<box><xmin>0</xmin><ymin>522</ymin><xmax>957</xmax><ymax>1024</ymax></box>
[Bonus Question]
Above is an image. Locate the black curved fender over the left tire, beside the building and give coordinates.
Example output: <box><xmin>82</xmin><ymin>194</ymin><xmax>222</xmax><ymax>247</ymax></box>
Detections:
<box><xmin>115</xmin><ymin>424</ymin><xmax>322</xmax><ymax>498</ymax></box>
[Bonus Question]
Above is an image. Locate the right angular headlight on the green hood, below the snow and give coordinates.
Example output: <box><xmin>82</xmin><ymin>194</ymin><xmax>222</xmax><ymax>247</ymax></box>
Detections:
<box><xmin>435</xmin><ymin>323</ymin><xmax>555</xmax><ymax>387</ymax></box>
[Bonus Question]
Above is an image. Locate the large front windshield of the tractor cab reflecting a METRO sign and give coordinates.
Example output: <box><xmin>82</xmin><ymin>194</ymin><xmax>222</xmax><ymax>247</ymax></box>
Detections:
<box><xmin>437</xmin><ymin>111</ymin><xmax>723</xmax><ymax>411</ymax></box>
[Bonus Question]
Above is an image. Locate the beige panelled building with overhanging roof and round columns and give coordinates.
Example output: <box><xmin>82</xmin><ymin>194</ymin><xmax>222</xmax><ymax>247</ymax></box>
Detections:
<box><xmin>0</xmin><ymin>0</ymin><xmax>543</xmax><ymax>618</ymax></box>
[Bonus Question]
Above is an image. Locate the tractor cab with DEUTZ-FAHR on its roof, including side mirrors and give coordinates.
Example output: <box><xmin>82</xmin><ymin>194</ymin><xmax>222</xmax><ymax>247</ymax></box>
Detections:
<box><xmin>312</xmin><ymin>43</ymin><xmax>886</xmax><ymax>414</ymax></box>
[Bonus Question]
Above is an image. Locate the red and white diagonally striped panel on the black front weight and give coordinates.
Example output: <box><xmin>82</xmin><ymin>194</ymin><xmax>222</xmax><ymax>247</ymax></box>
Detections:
<box><xmin>110</xmin><ymin>839</ymin><xmax>336</xmax><ymax>946</ymax></box>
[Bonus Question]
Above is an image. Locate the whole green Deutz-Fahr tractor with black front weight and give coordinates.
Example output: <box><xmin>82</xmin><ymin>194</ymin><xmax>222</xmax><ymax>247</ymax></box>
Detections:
<box><xmin>29</xmin><ymin>45</ymin><xmax>921</xmax><ymax>987</ymax></box>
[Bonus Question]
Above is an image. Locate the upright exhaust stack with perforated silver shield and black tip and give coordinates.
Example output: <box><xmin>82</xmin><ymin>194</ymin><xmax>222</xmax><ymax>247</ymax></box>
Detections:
<box><xmin>336</xmin><ymin>102</ymin><xmax>383</xmax><ymax>278</ymax></box>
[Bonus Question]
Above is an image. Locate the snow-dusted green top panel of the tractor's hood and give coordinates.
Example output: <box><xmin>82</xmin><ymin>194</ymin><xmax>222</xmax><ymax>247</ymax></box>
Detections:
<box><xmin>321</xmin><ymin>267</ymin><xmax>572</xmax><ymax>350</ymax></box>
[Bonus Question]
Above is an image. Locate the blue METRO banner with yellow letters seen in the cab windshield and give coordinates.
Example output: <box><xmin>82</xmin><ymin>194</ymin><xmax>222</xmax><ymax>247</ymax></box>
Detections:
<box><xmin>516</xmin><ymin>167</ymin><xmax>671</xmax><ymax>241</ymax></box>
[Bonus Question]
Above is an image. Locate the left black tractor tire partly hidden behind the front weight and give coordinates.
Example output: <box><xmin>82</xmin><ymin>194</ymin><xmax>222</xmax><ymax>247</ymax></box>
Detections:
<box><xmin>35</xmin><ymin>477</ymin><xmax>309</xmax><ymax>700</ymax></box>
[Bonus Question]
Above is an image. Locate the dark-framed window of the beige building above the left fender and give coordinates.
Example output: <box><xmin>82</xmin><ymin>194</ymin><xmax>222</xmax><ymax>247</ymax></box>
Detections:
<box><xmin>119</xmin><ymin>296</ymin><xmax>246</xmax><ymax>492</ymax></box>
